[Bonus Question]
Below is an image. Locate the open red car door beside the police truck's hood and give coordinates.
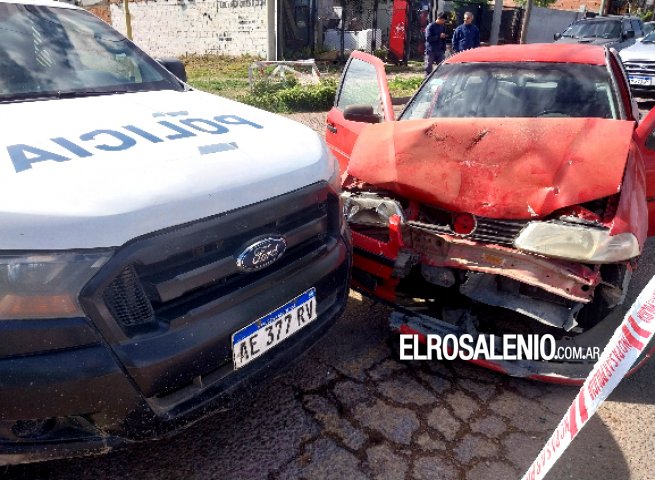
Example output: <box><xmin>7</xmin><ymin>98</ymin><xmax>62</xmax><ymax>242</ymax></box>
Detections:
<box><xmin>325</xmin><ymin>51</ymin><xmax>394</xmax><ymax>173</ymax></box>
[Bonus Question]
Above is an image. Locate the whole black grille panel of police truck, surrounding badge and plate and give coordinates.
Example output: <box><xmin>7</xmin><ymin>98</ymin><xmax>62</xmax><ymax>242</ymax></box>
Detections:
<box><xmin>80</xmin><ymin>182</ymin><xmax>350</xmax><ymax>404</ymax></box>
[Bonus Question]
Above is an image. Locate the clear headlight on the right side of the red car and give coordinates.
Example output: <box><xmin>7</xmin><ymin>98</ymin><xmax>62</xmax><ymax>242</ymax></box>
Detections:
<box><xmin>514</xmin><ymin>222</ymin><xmax>640</xmax><ymax>263</ymax></box>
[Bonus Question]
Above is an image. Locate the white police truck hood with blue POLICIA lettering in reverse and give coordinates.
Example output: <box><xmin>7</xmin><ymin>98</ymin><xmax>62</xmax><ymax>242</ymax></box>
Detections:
<box><xmin>0</xmin><ymin>91</ymin><xmax>334</xmax><ymax>250</ymax></box>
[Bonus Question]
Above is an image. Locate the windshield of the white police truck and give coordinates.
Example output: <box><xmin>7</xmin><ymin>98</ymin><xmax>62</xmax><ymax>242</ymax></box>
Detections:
<box><xmin>0</xmin><ymin>3</ymin><xmax>183</xmax><ymax>101</ymax></box>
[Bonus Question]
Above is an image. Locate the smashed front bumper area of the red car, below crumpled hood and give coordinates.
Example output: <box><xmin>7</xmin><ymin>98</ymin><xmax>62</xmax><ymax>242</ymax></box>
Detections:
<box><xmin>344</xmin><ymin>192</ymin><xmax>644</xmax><ymax>384</ymax></box>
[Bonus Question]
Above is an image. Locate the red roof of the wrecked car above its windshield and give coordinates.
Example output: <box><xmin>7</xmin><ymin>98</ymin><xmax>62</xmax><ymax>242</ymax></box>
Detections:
<box><xmin>445</xmin><ymin>43</ymin><xmax>605</xmax><ymax>65</ymax></box>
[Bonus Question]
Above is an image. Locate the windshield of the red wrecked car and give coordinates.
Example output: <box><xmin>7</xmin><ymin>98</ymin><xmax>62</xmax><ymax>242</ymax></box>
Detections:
<box><xmin>401</xmin><ymin>62</ymin><xmax>619</xmax><ymax>120</ymax></box>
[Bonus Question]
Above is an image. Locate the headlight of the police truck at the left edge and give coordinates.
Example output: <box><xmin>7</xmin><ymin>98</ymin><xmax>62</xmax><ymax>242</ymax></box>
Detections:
<box><xmin>0</xmin><ymin>250</ymin><xmax>112</xmax><ymax>320</ymax></box>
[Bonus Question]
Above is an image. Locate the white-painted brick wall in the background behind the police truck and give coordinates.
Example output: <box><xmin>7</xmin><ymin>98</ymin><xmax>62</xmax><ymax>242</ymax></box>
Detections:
<box><xmin>110</xmin><ymin>0</ymin><xmax>268</xmax><ymax>57</ymax></box>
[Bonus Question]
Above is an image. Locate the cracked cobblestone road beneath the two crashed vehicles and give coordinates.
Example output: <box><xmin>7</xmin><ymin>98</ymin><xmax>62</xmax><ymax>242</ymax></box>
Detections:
<box><xmin>5</xmin><ymin>115</ymin><xmax>655</xmax><ymax>480</ymax></box>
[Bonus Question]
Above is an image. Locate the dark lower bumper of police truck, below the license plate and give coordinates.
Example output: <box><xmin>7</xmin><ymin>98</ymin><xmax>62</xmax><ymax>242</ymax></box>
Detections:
<box><xmin>0</xmin><ymin>243</ymin><xmax>350</xmax><ymax>465</ymax></box>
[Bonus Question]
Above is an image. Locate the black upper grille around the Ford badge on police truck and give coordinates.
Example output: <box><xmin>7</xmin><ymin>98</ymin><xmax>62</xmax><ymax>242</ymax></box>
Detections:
<box><xmin>95</xmin><ymin>184</ymin><xmax>338</xmax><ymax>335</ymax></box>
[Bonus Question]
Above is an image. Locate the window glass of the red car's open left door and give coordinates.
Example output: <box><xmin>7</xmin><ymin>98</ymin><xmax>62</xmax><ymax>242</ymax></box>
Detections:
<box><xmin>336</xmin><ymin>58</ymin><xmax>382</xmax><ymax>115</ymax></box>
